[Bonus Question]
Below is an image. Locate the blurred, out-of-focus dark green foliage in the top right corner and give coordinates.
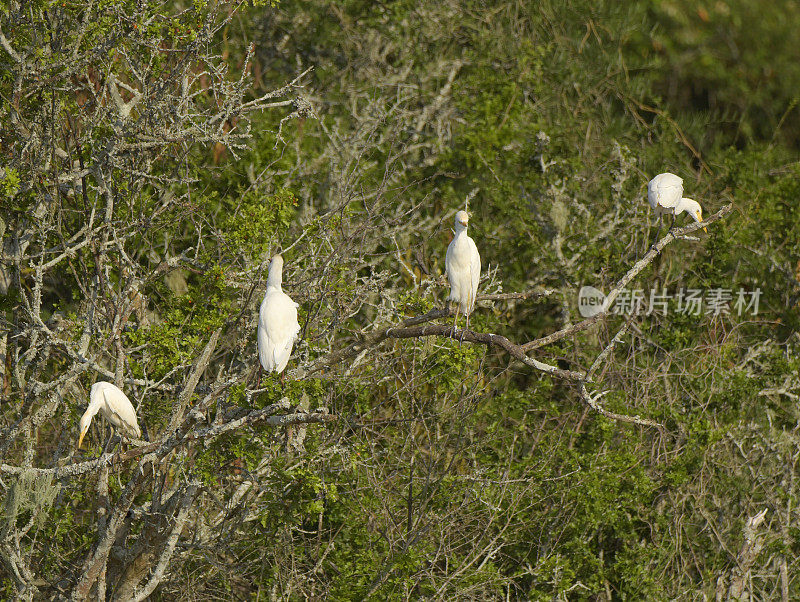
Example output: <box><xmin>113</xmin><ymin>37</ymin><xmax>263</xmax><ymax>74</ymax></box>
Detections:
<box><xmin>630</xmin><ymin>0</ymin><xmax>800</xmax><ymax>146</ymax></box>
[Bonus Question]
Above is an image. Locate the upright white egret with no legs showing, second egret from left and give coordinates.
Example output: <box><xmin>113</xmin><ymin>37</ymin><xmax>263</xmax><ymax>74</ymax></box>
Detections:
<box><xmin>258</xmin><ymin>255</ymin><xmax>300</xmax><ymax>374</ymax></box>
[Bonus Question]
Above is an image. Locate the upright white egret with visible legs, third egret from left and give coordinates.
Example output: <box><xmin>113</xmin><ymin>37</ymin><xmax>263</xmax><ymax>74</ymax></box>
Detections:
<box><xmin>444</xmin><ymin>211</ymin><xmax>481</xmax><ymax>330</ymax></box>
